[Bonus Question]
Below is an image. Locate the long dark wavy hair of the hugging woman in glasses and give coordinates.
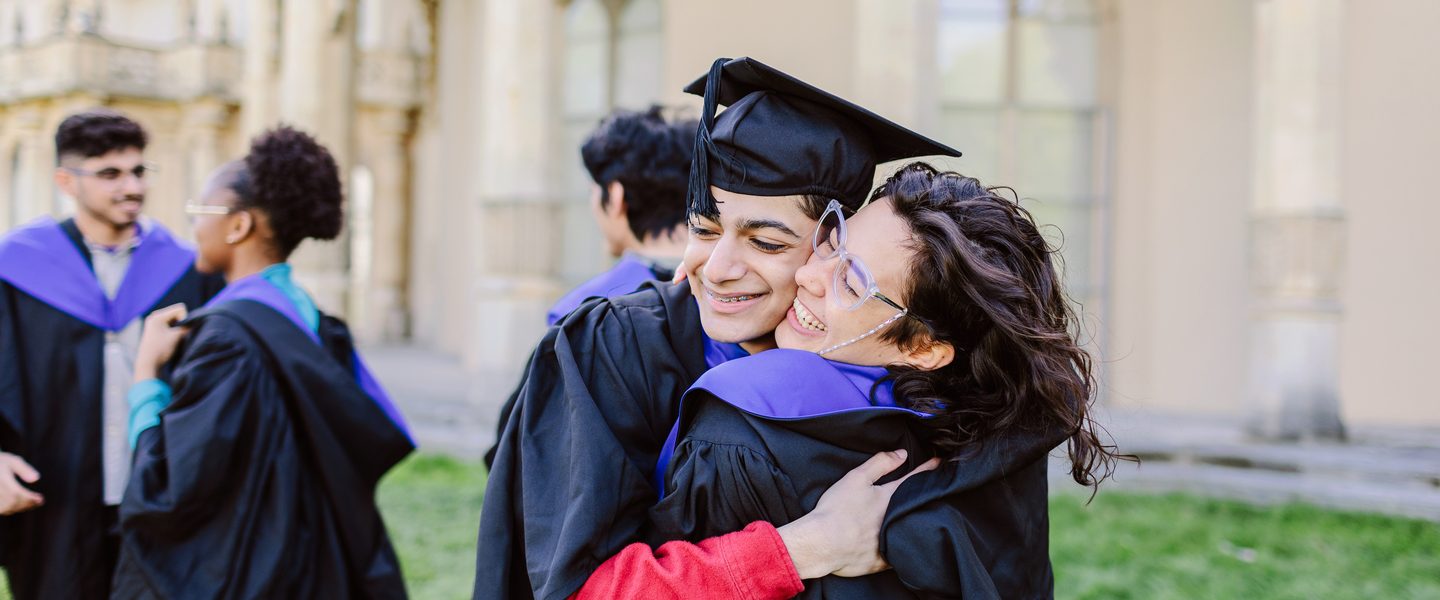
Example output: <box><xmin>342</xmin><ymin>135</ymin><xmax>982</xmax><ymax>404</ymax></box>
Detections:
<box><xmin>871</xmin><ymin>163</ymin><xmax>1133</xmax><ymax>486</ymax></box>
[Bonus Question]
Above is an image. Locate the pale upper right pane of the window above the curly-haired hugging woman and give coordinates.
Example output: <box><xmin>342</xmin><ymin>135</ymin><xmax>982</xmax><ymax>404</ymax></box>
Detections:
<box><xmin>1017</xmin><ymin>19</ymin><xmax>1096</xmax><ymax>108</ymax></box>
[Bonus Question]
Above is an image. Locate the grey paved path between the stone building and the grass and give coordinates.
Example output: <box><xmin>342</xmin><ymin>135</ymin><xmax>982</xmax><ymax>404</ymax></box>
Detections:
<box><xmin>364</xmin><ymin>347</ymin><xmax>1440</xmax><ymax>521</ymax></box>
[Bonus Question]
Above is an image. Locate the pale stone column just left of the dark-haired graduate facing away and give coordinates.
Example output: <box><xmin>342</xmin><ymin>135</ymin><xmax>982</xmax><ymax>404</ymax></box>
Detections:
<box><xmin>456</xmin><ymin>0</ymin><xmax>563</xmax><ymax>391</ymax></box>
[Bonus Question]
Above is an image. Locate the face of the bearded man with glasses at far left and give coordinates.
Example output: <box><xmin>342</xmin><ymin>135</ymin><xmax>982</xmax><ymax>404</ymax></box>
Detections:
<box><xmin>56</xmin><ymin>148</ymin><xmax>148</xmax><ymax>230</ymax></box>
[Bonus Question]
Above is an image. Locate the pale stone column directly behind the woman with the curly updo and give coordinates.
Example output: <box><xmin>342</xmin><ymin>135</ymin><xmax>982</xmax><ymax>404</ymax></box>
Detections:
<box><xmin>275</xmin><ymin>0</ymin><xmax>356</xmax><ymax>315</ymax></box>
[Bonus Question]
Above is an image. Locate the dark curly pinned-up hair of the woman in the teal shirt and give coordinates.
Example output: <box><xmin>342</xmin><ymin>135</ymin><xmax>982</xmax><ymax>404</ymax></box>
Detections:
<box><xmin>223</xmin><ymin>125</ymin><xmax>344</xmax><ymax>259</ymax></box>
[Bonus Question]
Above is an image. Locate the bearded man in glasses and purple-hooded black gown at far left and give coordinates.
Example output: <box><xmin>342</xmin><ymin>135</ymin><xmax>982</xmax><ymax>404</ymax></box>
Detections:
<box><xmin>0</xmin><ymin>109</ymin><xmax>223</xmax><ymax>600</ymax></box>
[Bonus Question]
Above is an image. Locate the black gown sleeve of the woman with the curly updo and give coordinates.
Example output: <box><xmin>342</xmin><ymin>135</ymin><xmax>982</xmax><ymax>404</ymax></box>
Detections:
<box><xmin>121</xmin><ymin>317</ymin><xmax>279</xmax><ymax>540</ymax></box>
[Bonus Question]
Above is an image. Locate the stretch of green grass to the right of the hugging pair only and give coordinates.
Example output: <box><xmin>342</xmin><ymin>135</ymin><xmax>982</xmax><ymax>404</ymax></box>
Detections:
<box><xmin>1050</xmin><ymin>489</ymin><xmax>1440</xmax><ymax>599</ymax></box>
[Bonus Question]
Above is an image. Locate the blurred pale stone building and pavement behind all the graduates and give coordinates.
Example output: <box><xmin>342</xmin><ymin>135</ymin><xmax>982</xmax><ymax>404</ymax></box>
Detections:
<box><xmin>0</xmin><ymin>0</ymin><xmax>1440</xmax><ymax>597</ymax></box>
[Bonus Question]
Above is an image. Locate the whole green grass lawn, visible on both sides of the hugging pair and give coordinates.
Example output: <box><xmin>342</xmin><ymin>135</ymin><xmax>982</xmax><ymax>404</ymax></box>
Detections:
<box><xmin>0</xmin><ymin>456</ymin><xmax>1440</xmax><ymax>600</ymax></box>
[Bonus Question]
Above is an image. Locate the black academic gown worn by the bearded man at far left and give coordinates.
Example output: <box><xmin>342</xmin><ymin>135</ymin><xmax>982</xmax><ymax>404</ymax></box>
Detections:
<box><xmin>0</xmin><ymin>222</ymin><xmax>225</xmax><ymax>600</ymax></box>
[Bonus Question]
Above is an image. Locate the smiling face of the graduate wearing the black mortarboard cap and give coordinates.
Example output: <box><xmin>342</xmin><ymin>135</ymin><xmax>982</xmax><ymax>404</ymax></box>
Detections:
<box><xmin>681</xmin><ymin>187</ymin><xmax>815</xmax><ymax>345</ymax></box>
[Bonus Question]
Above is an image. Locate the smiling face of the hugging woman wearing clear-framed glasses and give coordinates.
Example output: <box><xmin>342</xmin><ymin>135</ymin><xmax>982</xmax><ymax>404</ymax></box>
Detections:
<box><xmin>775</xmin><ymin>199</ymin><xmax>916</xmax><ymax>367</ymax></box>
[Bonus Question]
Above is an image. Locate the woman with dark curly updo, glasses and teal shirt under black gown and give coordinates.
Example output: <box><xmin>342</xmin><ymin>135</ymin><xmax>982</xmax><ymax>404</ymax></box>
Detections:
<box><xmin>112</xmin><ymin>127</ymin><xmax>413</xmax><ymax>599</ymax></box>
